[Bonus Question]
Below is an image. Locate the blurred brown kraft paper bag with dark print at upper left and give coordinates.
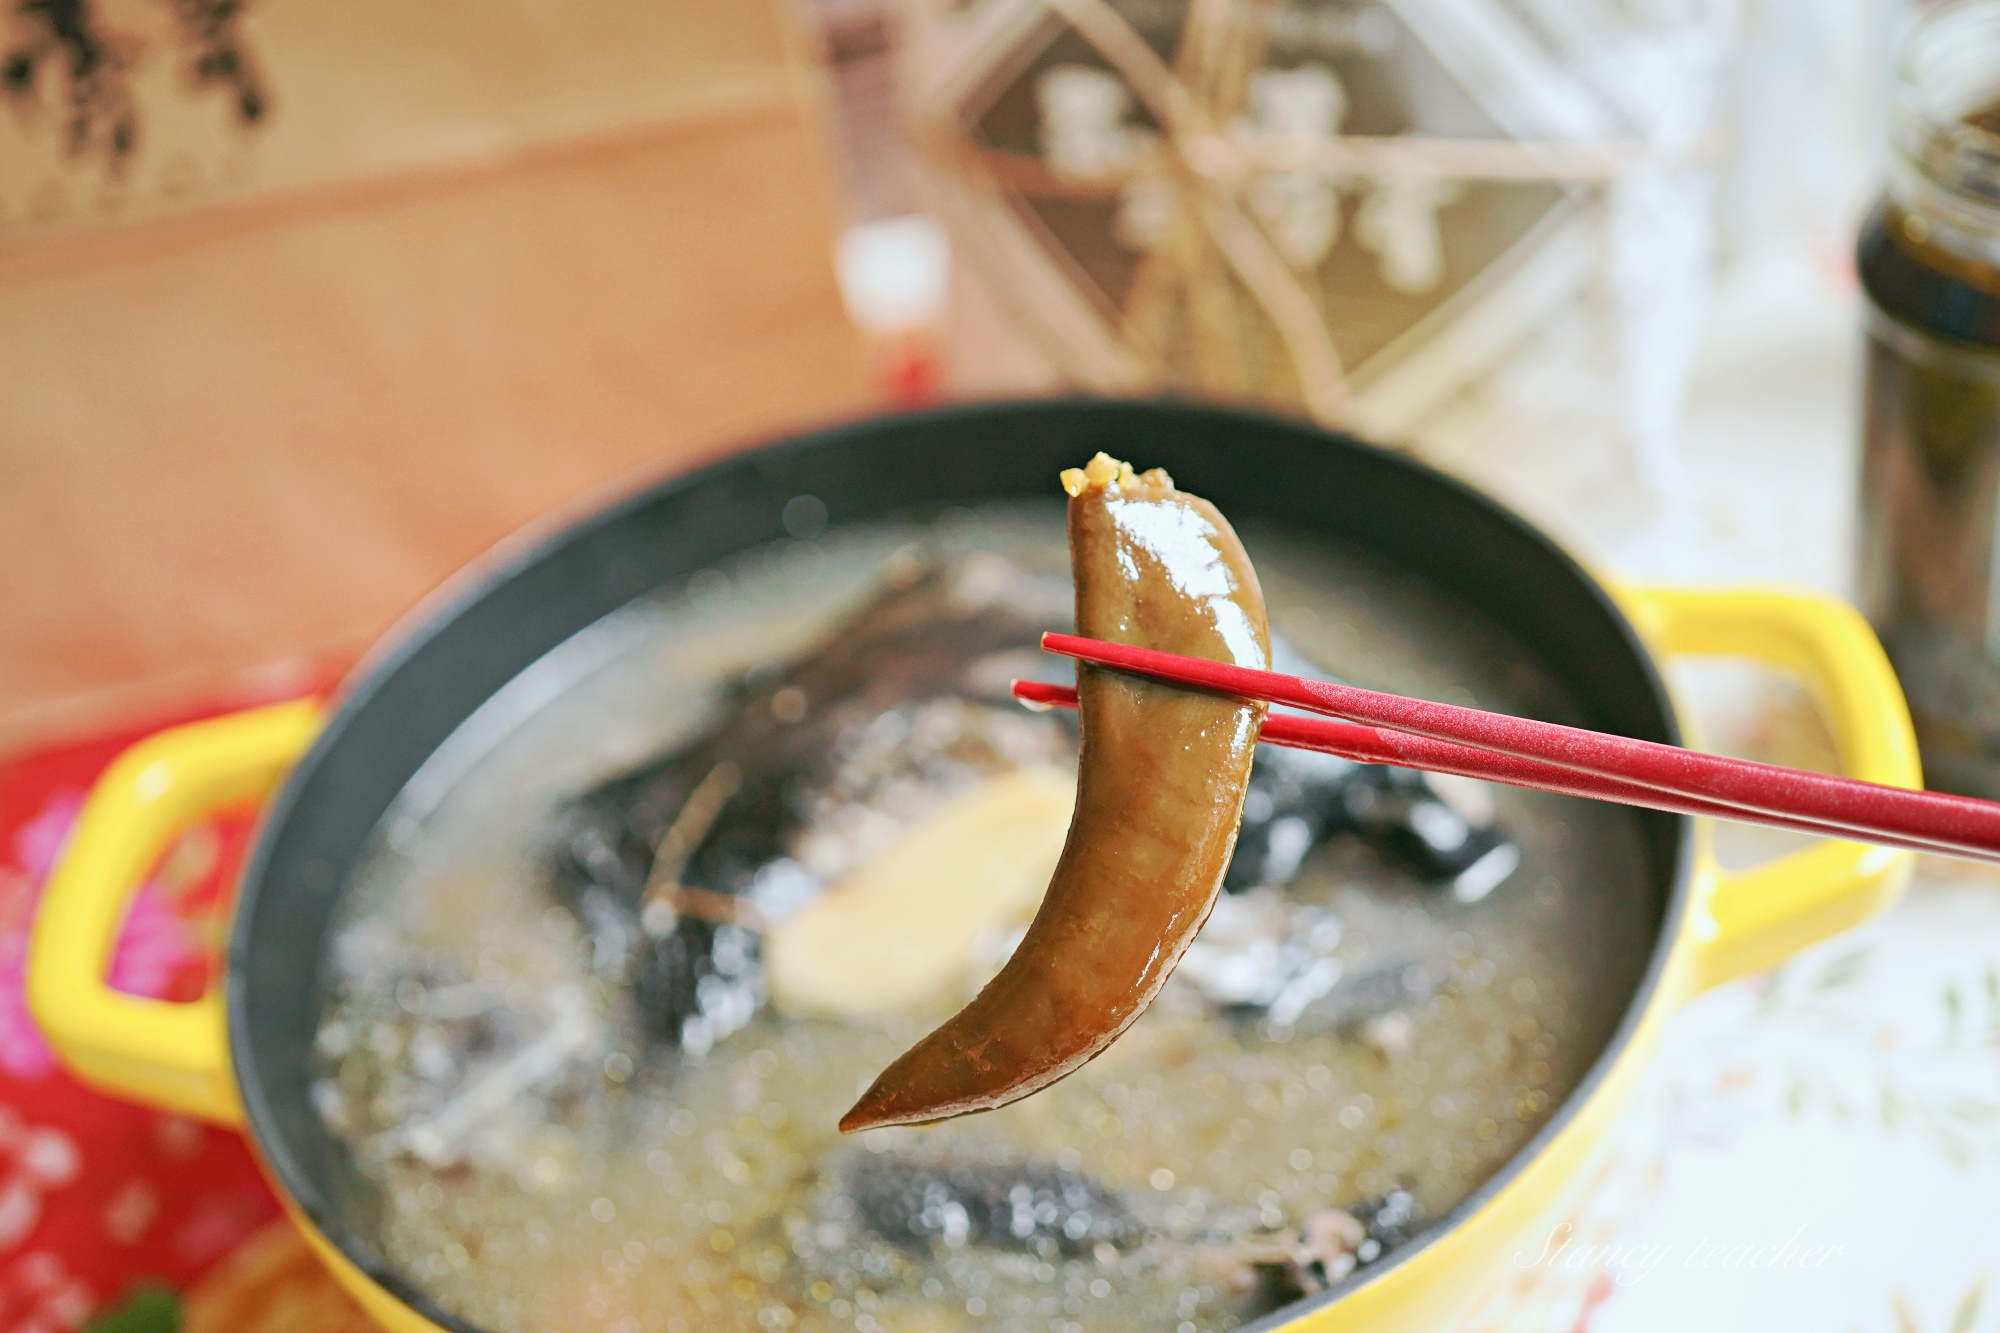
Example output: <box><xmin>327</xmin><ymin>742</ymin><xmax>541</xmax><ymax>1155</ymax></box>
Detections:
<box><xmin>0</xmin><ymin>0</ymin><xmax>862</xmax><ymax>747</ymax></box>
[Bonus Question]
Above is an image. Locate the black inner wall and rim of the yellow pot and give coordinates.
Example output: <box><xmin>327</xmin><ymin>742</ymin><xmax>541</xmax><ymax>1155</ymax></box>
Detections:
<box><xmin>228</xmin><ymin>400</ymin><xmax>1686</xmax><ymax>1325</ymax></box>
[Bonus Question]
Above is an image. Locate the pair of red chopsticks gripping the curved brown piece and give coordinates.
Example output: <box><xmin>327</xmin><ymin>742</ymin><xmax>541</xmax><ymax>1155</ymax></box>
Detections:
<box><xmin>1014</xmin><ymin>634</ymin><xmax>2000</xmax><ymax>863</ymax></box>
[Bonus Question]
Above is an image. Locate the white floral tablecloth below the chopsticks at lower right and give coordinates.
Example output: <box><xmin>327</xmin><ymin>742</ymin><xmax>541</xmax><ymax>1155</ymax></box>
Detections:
<box><xmin>1480</xmin><ymin>861</ymin><xmax>2000</xmax><ymax>1333</ymax></box>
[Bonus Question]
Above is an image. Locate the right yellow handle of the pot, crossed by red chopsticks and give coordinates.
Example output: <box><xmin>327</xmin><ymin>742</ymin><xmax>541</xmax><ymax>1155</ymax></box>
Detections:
<box><xmin>1616</xmin><ymin>588</ymin><xmax>1924</xmax><ymax>989</ymax></box>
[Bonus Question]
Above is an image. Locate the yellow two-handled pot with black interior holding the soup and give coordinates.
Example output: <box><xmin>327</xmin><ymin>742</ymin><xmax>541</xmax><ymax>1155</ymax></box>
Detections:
<box><xmin>28</xmin><ymin>402</ymin><xmax>1920</xmax><ymax>1333</ymax></box>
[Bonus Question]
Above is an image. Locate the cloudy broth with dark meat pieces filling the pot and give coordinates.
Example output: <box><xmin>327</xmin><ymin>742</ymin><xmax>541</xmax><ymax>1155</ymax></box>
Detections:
<box><xmin>316</xmin><ymin>504</ymin><xmax>1650</xmax><ymax>1333</ymax></box>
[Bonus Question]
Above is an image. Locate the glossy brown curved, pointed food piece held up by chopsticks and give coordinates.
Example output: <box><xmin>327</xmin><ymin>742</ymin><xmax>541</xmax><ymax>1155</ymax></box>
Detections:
<box><xmin>840</xmin><ymin>454</ymin><xmax>1270</xmax><ymax>1133</ymax></box>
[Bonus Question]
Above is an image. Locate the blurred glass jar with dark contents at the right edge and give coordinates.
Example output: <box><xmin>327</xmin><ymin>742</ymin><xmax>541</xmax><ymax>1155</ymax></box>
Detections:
<box><xmin>1858</xmin><ymin>0</ymin><xmax>2000</xmax><ymax>797</ymax></box>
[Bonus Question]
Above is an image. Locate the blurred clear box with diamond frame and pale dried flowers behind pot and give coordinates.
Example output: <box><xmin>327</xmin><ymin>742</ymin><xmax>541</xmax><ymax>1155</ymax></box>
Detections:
<box><xmin>904</xmin><ymin>0</ymin><xmax>1736</xmax><ymax>490</ymax></box>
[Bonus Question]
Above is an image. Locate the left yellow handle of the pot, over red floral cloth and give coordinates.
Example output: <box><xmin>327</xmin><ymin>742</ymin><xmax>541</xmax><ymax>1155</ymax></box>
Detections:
<box><xmin>28</xmin><ymin>701</ymin><xmax>320</xmax><ymax>1125</ymax></box>
